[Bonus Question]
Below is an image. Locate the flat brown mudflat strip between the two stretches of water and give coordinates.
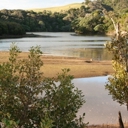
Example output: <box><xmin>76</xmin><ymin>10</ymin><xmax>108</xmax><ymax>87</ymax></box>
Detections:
<box><xmin>0</xmin><ymin>51</ymin><xmax>114</xmax><ymax>78</ymax></box>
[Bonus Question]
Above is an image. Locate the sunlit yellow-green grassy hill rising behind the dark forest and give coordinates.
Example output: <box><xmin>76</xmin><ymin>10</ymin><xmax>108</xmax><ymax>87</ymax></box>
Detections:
<box><xmin>28</xmin><ymin>3</ymin><xmax>83</xmax><ymax>12</ymax></box>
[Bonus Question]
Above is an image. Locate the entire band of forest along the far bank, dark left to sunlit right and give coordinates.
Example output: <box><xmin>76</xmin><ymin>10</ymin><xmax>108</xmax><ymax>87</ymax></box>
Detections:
<box><xmin>0</xmin><ymin>0</ymin><xmax>128</xmax><ymax>35</ymax></box>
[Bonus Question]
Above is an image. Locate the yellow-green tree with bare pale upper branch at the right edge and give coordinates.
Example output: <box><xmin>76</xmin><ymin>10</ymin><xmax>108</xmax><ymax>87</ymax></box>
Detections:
<box><xmin>106</xmin><ymin>19</ymin><xmax>128</xmax><ymax>109</ymax></box>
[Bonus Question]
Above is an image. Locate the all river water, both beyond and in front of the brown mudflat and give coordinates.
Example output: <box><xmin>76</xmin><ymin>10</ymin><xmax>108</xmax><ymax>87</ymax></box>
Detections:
<box><xmin>0</xmin><ymin>32</ymin><xmax>128</xmax><ymax>124</ymax></box>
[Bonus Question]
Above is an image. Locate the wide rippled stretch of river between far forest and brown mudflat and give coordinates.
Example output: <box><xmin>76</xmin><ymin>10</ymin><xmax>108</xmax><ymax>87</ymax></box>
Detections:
<box><xmin>0</xmin><ymin>32</ymin><xmax>111</xmax><ymax>60</ymax></box>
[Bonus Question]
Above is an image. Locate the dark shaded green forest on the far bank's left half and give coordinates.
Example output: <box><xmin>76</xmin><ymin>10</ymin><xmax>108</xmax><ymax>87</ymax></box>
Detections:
<box><xmin>0</xmin><ymin>9</ymin><xmax>71</xmax><ymax>35</ymax></box>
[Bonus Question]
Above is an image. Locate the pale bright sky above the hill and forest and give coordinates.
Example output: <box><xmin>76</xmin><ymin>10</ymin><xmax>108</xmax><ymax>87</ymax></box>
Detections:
<box><xmin>0</xmin><ymin>0</ymin><xmax>84</xmax><ymax>10</ymax></box>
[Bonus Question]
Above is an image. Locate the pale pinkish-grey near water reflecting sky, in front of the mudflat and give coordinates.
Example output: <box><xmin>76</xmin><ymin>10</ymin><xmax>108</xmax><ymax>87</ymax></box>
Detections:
<box><xmin>73</xmin><ymin>77</ymin><xmax>128</xmax><ymax>124</ymax></box>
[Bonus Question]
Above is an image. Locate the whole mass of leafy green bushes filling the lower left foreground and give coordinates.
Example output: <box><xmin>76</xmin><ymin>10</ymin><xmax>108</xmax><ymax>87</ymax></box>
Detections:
<box><xmin>0</xmin><ymin>44</ymin><xmax>85</xmax><ymax>128</ymax></box>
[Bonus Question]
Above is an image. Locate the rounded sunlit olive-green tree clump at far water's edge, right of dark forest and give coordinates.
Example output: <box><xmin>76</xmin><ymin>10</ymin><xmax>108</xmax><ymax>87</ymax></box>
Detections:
<box><xmin>72</xmin><ymin>10</ymin><xmax>105</xmax><ymax>34</ymax></box>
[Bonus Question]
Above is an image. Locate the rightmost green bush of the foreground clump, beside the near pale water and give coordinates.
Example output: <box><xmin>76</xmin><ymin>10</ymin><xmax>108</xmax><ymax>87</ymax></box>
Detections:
<box><xmin>44</xmin><ymin>69</ymin><xmax>85</xmax><ymax>128</ymax></box>
